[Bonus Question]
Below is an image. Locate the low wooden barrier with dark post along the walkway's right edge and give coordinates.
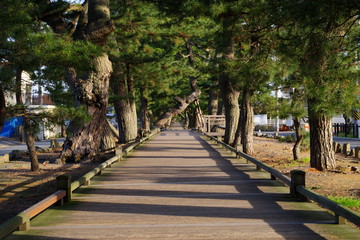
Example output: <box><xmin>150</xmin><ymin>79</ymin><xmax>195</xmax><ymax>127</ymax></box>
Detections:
<box><xmin>205</xmin><ymin>134</ymin><xmax>360</xmax><ymax>227</ymax></box>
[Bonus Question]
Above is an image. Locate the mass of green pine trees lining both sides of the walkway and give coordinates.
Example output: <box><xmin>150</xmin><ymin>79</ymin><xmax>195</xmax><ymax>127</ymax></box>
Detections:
<box><xmin>0</xmin><ymin>0</ymin><xmax>359</xmax><ymax>170</ymax></box>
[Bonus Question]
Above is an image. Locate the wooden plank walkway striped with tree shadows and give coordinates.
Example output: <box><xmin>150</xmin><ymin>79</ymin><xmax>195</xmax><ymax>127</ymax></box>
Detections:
<box><xmin>6</xmin><ymin>126</ymin><xmax>360</xmax><ymax>240</ymax></box>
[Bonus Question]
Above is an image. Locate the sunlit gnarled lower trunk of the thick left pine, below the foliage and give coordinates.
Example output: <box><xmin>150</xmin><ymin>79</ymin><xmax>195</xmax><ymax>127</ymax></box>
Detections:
<box><xmin>60</xmin><ymin>54</ymin><xmax>115</xmax><ymax>161</ymax></box>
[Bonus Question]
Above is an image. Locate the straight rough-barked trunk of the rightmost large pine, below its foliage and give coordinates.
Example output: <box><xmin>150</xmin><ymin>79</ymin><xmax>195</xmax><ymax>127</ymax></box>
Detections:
<box><xmin>309</xmin><ymin>103</ymin><xmax>336</xmax><ymax>171</ymax></box>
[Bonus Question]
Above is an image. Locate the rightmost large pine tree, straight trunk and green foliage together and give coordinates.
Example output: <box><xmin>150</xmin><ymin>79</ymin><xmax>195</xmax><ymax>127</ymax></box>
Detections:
<box><xmin>272</xmin><ymin>1</ymin><xmax>359</xmax><ymax>170</ymax></box>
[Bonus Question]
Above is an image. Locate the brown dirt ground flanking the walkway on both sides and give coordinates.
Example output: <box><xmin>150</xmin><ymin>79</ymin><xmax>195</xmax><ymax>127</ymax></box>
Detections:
<box><xmin>0</xmin><ymin>137</ymin><xmax>360</xmax><ymax>224</ymax></box>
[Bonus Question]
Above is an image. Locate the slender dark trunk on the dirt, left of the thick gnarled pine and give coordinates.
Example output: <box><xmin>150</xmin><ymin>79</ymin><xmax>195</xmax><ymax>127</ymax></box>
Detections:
<box><xmin>24</xmin><ymin>114</ymin><xmax>40</xmax><ymax>172</ymax></box>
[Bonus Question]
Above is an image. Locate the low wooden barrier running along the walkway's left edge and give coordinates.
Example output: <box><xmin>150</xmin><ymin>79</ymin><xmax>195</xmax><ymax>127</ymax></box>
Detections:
<box><xmin>0</xmin><ymin>129</ymin><xmax>160</xmax><ymax>239</ymax></box>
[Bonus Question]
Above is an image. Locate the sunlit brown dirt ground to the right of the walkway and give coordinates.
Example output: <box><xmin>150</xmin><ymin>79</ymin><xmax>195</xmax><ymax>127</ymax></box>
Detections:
<box><xmin>254</xmin><ymin>137</ymin><xmax>360</xmax><ymax>202</ymax></box>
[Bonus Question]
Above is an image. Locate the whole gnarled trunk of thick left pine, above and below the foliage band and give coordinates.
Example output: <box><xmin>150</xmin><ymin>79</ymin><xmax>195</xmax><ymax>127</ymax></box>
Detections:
<box><xmin>59</xmin><ymin>0</ymin><xmax>115</xmax><ymax>161</ymax></box>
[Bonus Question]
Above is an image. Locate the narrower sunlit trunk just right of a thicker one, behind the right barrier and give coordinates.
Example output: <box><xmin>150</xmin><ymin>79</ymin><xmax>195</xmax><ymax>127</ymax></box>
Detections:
<box><xmin>240</xmin><ymin>88</ymin><xmax>254</xmax><ymax>155</ymax></box>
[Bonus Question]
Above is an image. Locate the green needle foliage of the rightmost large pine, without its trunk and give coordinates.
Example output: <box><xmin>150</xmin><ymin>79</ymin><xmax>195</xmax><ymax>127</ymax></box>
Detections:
<box><xmin>277</xmin><ymin>1</ymin><xmax>359</xmax><ymax>116</ymax></box>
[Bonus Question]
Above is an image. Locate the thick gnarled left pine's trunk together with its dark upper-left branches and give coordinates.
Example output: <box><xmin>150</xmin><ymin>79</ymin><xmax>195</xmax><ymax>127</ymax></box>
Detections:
<box><xmin>37</xmin><ymin>0</ymin><xmax>115</xmax><ymax>160</ymax></box>
